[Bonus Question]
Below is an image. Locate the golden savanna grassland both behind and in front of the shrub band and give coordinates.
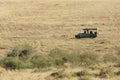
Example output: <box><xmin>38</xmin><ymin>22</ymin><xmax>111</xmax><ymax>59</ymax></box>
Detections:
<box><xmin>0</xmin><ymin>0</ymin><xmax>120</xmax><ymax>80</ymax></box>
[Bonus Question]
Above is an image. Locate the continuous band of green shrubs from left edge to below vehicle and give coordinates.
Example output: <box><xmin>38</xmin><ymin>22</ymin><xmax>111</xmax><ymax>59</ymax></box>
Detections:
<box><xmin>0</xmin><ymin>45</ymin><xmax>98</xmax><ymax>69</ymax></box>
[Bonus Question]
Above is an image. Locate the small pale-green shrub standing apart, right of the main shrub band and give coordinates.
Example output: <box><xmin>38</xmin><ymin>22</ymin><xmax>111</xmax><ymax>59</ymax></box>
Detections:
<box><xmin>103</xmin><ymin>54</ymin><xmax>117</xmax><ymax>62</ymax></box>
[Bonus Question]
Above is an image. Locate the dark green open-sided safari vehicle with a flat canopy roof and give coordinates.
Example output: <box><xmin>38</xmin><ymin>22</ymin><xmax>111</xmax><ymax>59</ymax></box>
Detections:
<box><xmin>75</xmin><ymin>28</ymin><xmax>97</xmax><ymax>39</ymax></box>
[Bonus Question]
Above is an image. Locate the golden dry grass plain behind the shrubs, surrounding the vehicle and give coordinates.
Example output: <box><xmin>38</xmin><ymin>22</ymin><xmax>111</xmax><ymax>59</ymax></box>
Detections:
<box><xmin>0</xmin><ymin>0</ymin><xmax>120</xmax><ymax>56</ymax></box>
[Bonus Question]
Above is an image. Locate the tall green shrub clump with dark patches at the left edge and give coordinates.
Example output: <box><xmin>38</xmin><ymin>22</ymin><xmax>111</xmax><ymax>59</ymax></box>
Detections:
<box><xmin>0</xmin><ymin>45</ymin><xmax>34</xmax><ymax>70</ymax></box>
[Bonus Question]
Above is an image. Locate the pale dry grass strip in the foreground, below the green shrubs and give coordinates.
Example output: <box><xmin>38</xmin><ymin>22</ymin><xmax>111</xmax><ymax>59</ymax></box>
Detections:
<box><xmin>0</xmin><ymin>67</ymin><xmax>120</xmax><ymax>80</ymax></box>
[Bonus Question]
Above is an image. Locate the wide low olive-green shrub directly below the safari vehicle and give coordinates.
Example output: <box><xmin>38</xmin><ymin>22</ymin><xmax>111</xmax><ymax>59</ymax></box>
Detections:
<box><xmin>68</xmin><ymin>53</ymin><xmax>99</xmax><ymax>66</ymax></box>
